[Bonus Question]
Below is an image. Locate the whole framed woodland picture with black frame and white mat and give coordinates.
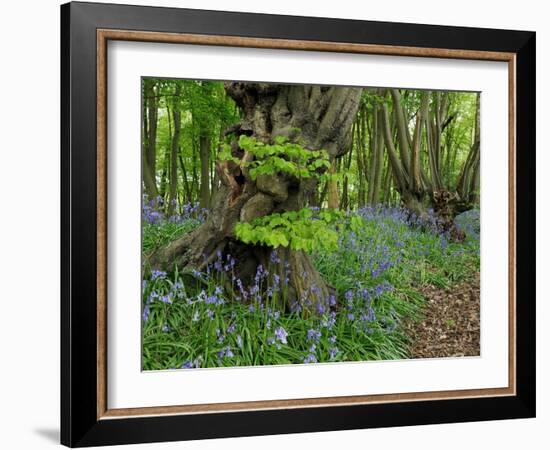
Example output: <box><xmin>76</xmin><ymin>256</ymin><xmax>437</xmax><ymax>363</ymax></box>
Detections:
<box><xmin>61</xmin><ymin>2</ymin><xmax>535</xmax><ymax>447</ymax></box>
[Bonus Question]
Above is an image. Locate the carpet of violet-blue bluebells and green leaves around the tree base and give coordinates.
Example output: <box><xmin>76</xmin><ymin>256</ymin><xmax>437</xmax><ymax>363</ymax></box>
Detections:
<box><xmin>142</xmin><ymin>196</ymin><xmax>479</xmax><ymax>370</ymax></box>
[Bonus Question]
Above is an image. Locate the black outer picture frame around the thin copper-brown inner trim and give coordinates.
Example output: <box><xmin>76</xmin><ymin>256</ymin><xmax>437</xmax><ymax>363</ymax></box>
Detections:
<box><xmin>61</xmin><ymin>2</ymin><xmax>536</xmax><ymax>447</ymax></box>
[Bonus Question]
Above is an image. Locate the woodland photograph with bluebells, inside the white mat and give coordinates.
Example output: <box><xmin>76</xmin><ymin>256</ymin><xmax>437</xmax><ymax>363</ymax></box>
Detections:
<box><xmin>141</xmin><ymin>77</ymin><xmax>483</xmax><ymax>371</ymax></box>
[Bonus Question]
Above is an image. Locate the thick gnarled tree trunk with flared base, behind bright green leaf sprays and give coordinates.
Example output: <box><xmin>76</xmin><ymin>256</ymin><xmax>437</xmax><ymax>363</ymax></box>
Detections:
<box><xmin>150</xmin><ymin>82</ymin><xmax>361</xmax><ymax>307</ymax></box>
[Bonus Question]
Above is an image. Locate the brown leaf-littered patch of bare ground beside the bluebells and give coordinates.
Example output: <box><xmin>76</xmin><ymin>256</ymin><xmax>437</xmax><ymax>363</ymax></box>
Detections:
<box><xmin>406</xmin><ymin>272</ymin><xmax>480</xmax><ymax>358</ymax></box>
